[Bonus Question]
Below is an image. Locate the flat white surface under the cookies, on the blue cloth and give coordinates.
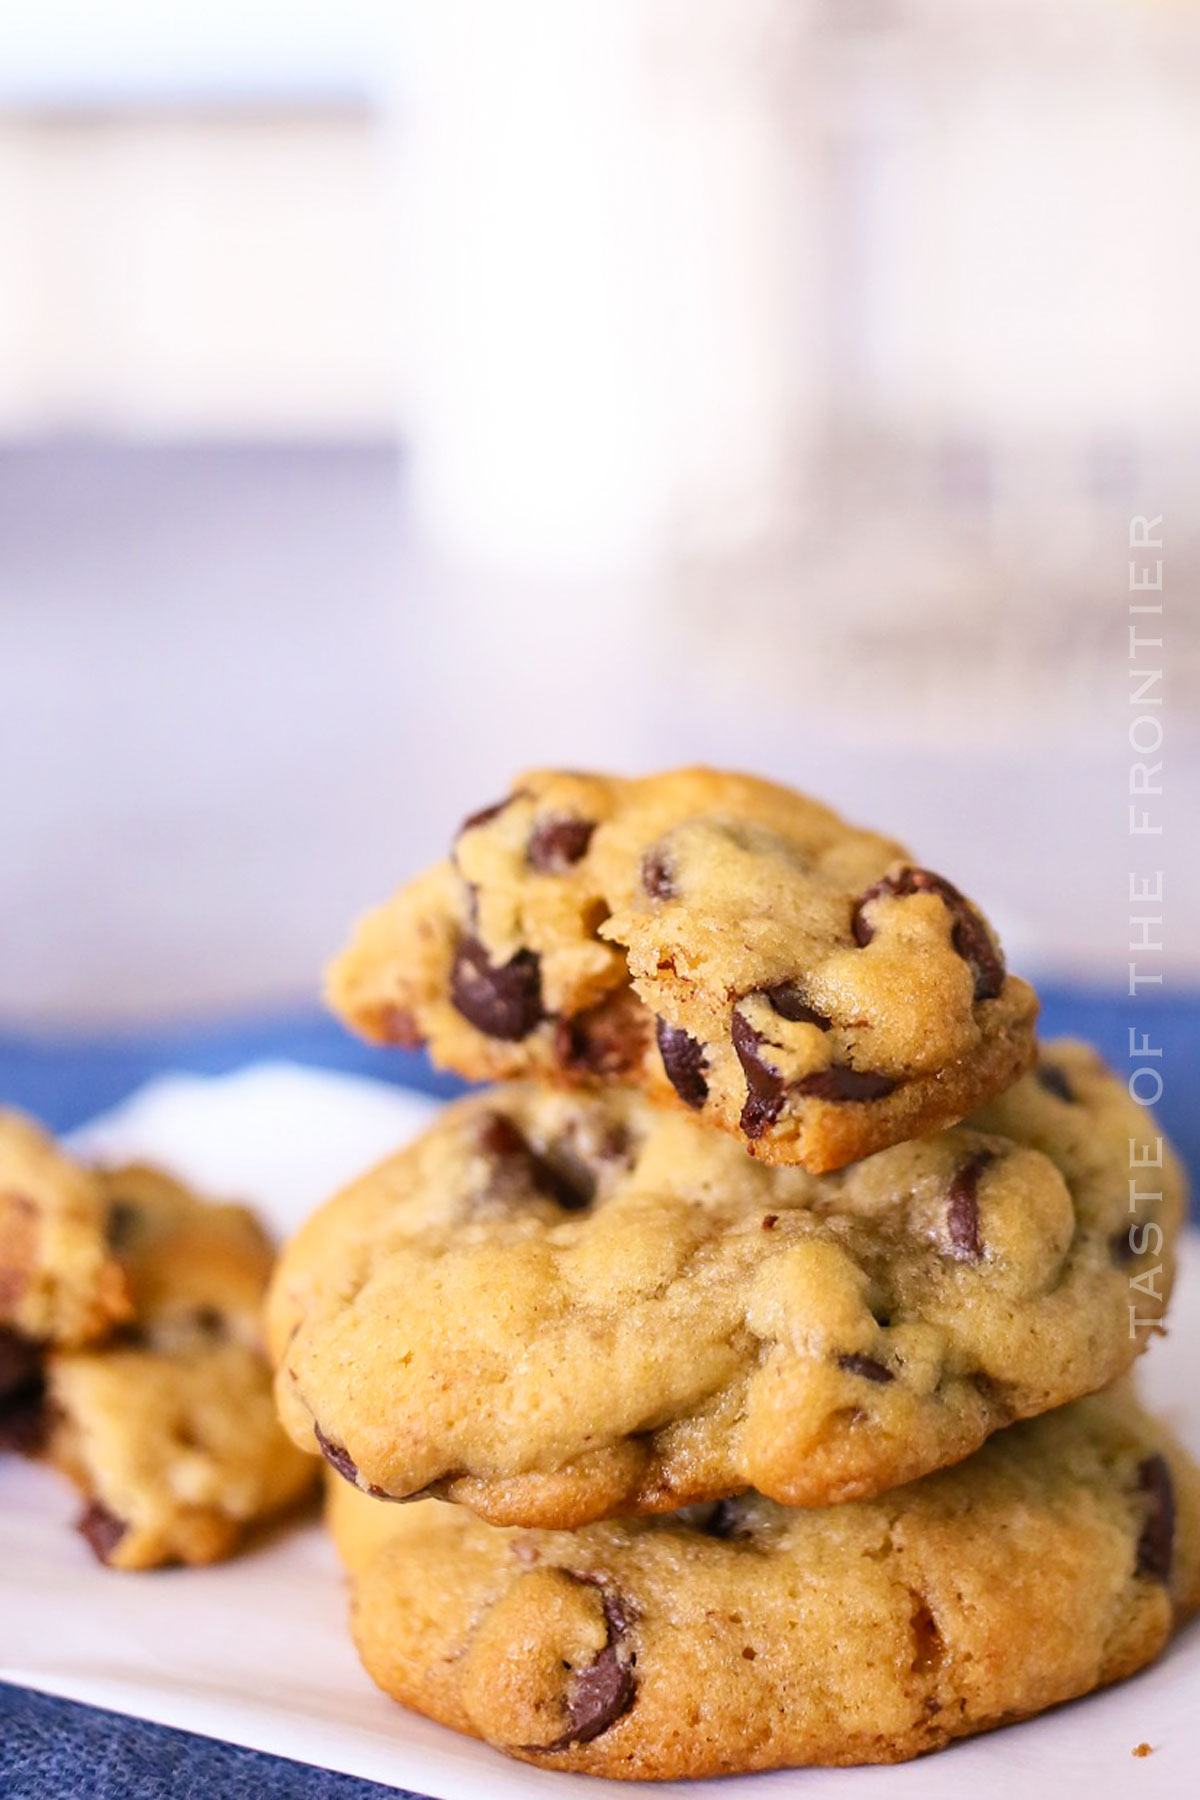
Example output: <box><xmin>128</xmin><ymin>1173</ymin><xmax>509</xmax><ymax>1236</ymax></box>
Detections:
<box><xmin>0</xmin><ymin>1066</ymin><xmax>1200</xmax><ymax>1800</ymax></box>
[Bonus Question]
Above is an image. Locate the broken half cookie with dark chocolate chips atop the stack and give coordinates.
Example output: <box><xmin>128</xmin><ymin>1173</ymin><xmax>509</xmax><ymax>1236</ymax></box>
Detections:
<box><xmin>329</xmin><ymin>769</ymin><xmax>1036</xmax><ymax>1172</ymax></box>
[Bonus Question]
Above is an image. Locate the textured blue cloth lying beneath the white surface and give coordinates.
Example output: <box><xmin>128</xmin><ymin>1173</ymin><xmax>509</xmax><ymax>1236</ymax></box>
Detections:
<box><xmin>0</xmin><ymin>986</ymin><xmax>1200</xmax><ymax>1800</ymax></box>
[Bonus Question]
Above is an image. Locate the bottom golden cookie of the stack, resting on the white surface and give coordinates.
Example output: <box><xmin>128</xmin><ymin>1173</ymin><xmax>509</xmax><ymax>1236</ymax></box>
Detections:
<box><xmin>327</xmin><ymin>1388</ymin><xmax>1200</xmax><ymax>1778</ymax></box>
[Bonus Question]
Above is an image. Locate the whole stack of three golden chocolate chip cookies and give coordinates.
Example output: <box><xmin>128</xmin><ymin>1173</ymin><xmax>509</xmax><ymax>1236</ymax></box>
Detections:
<box><xmin>270</xmin><ymin>770</ymin><xmax>1200</xmax><ymax>1777</ymax></box>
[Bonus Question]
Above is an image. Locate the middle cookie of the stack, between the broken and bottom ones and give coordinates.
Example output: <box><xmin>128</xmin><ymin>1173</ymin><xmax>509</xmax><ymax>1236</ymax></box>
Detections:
<box><xmin>268</xmin><ymin>1044</ymin><xmax>1184</xmax><ymax>1528</ymax></box>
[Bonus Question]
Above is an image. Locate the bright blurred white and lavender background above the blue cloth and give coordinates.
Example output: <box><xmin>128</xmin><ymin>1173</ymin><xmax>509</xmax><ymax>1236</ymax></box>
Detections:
<box><xmin>0</xmin><ymin>0</ymin><xmax>1200</xmax><ymax>1037</ymax></box>
